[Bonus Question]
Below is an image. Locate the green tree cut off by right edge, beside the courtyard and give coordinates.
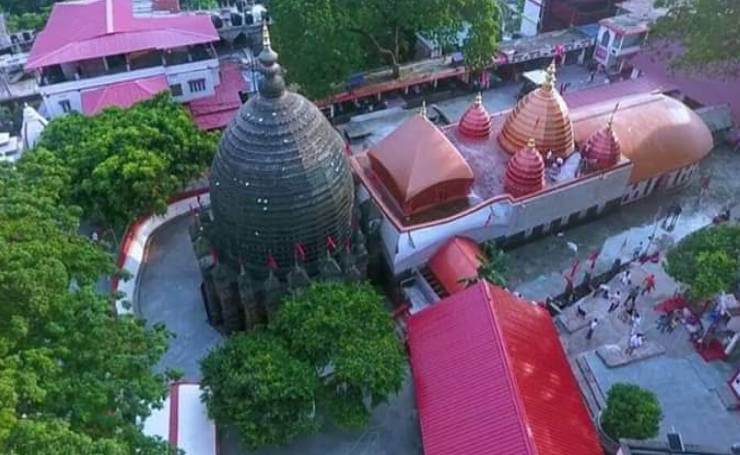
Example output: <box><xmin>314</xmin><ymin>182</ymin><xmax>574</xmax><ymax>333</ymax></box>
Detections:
<box><xmin>666</xmin><ymin>225</ymin><xmax>740</xmax><ymax>299</ymax></box>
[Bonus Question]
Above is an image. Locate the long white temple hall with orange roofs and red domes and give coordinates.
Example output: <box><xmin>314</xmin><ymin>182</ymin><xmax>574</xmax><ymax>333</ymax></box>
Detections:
<box><xmin>351</xmin><ymin>61</ymin><xmax>713</xmax><ymax>276</ymax></box>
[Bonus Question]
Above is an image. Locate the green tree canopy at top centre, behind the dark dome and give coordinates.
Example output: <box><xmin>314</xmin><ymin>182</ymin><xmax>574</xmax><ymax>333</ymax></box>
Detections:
<box><xmin>271</xmin><ymin>0</ymin><xmax>501</xmax><ymax>98</ymax></box>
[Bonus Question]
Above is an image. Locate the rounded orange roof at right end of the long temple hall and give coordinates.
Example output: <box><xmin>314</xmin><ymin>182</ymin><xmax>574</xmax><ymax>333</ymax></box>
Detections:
<box><xmin>573</xmin><ymin>94</ymin><xmax>714</xmax><ymax>183</ymax></box>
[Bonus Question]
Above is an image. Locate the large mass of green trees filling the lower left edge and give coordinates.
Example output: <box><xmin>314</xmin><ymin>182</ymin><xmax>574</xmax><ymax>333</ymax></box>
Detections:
<box><xmin>0</xmin><ymin>156</ymin><xmax>174</xmax><ymax>455</ymax></box>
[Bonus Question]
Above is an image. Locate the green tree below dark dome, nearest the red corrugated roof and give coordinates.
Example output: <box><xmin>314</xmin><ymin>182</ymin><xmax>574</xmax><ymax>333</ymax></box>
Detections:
<box><xmin>271</xmin><ymin>283</ymin><xmax>405</xmax><ymax>428</ymax></box>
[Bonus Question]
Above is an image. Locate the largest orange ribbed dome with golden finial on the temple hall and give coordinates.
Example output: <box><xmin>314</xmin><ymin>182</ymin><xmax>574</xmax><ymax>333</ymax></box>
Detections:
<box><xmin>498</xmin><ymin>64</ymin><xmax>574</xmax><ymax>157</ymax></box>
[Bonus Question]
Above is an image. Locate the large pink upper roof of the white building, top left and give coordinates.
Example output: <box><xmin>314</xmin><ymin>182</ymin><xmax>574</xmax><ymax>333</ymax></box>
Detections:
<box><xmin>26</xmin><ymin>0</ymin><xmax>218</xmax><ymax>70</ymax></box>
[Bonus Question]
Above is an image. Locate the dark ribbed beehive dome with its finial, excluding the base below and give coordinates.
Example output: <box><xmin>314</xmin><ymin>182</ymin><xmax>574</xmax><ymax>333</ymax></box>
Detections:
<box><xmin>210</xmin><ymin>27</ymin><xmax>354</xmax><ymax>276</ymax></box>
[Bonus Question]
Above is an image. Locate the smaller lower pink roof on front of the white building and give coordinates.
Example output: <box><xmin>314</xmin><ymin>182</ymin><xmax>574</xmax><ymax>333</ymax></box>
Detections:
<box><xmin>82</xmin><ymin>76</ymin><xmax>169</xmax><ymax>115</ymax></box>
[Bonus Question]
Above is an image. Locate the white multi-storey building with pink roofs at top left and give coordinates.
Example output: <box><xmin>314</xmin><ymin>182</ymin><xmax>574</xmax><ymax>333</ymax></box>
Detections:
<box><xmin>25</xmin><ymin>0</ymin><xmax>220</xmax><ymax>118</ymax></box>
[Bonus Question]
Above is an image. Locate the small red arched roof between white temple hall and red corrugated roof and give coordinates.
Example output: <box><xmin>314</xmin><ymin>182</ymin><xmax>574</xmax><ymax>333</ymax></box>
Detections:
<box><xmin>429</xmin><ymin>237</ymin><xmax>483</xmax><ymax>294</ymax></box>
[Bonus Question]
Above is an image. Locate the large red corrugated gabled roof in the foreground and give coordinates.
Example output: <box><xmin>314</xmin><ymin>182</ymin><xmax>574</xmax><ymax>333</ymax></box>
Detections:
<box><xmin>408</xmin><ymin>283</ymin><xmax>602</xmax><ymax>455</ymax></box>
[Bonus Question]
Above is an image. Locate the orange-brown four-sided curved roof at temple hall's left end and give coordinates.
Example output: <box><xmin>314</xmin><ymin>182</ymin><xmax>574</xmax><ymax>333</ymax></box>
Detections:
<box><xmin>368</xmin><ymin>115</ymin><xmax>474</xmax><ymax>203</ymax></box>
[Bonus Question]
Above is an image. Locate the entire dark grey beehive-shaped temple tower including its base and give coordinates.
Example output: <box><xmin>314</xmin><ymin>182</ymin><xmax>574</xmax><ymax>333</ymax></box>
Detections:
<box><xmin>191</xmin><ymin>25</ymin><xmax>367</xmax><ymax>332</ymax></box>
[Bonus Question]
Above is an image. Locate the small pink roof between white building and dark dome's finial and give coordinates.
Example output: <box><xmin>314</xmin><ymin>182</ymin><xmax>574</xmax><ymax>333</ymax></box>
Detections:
<box><xmin>189</xmin><ymin>63</ymin><xmax>247</xmax><ymax>130</ymax></box>
